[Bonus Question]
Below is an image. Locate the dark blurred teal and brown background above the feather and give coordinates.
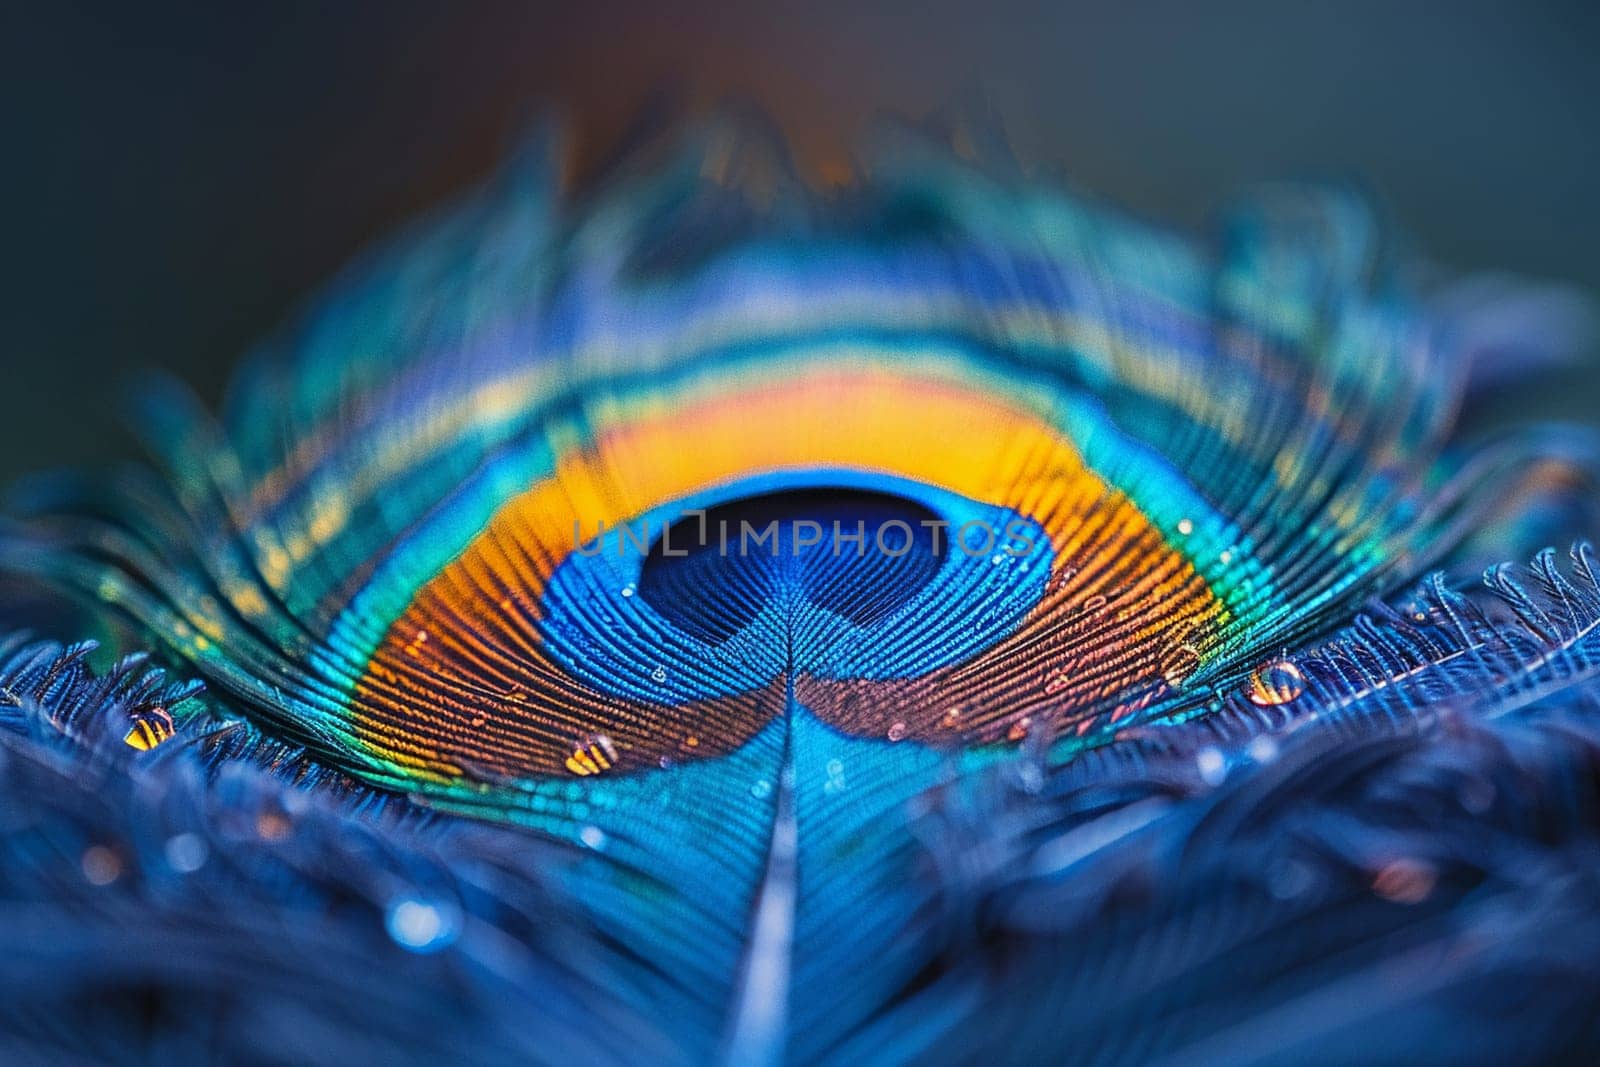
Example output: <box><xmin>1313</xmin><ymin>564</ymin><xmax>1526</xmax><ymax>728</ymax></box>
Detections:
<box><xmin>0</xmin><ymin>0</ymin><xmax>1600</xmax><ymax>480</ymax></box>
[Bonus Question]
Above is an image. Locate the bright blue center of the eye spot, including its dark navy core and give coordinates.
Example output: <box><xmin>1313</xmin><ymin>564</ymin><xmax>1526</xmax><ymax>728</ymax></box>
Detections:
<box><xmin>541</xmin><ymin>470</ymin><xmax>1053</xmax><ymax>704</ymax></box>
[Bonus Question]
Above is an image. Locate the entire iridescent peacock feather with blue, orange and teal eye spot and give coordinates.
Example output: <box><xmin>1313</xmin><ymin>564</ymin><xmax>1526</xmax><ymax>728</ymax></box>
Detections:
<box><xmin>0</xmin><ymin>116</ymin><xmax>1600</xmax><ymax>1064</ymax></box>
